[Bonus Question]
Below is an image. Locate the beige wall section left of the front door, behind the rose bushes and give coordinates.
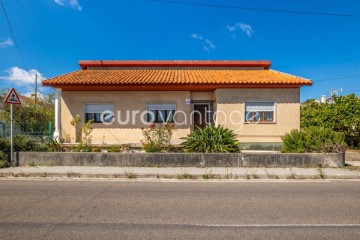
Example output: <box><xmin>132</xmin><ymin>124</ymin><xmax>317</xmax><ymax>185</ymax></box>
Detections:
<box><xmin>61</xmin><ymin>91</ymin><xmax>191</xmax><ymax>144</ymax></box>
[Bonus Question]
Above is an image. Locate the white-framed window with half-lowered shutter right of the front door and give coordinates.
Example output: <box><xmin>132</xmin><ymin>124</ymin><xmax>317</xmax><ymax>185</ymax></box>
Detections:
<box><xmin>245</xmin><ymin>102</ymin><xmax>275</xmax><ymax>123</ymax></box>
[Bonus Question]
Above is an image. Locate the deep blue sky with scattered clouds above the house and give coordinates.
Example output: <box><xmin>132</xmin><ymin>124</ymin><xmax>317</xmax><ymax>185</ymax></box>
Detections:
<box><xmin>0</xmin><ymin>0</ymin><xmax>360</xmax><ymax>101</ymax></box>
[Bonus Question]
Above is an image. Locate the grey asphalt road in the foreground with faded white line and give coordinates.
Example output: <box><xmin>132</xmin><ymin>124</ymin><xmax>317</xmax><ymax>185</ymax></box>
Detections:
<box><xmin>0</xmin><ymin>180</ymin><xmax>360</xmax><ymax>240</ymax></box>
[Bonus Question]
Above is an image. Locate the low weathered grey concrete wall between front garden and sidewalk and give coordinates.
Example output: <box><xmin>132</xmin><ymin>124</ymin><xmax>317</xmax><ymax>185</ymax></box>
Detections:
<box><xmin>15</xmin><ymin>152</ymin><xmax>345</xmax><ymax>167</ymax></box>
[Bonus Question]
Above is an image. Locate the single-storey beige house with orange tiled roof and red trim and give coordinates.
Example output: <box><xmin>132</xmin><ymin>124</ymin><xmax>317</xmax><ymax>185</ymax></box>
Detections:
<box><xmin>42</xmin><ymin>61</ymin><xmax>312</xmax><ymax>144</ymax></box>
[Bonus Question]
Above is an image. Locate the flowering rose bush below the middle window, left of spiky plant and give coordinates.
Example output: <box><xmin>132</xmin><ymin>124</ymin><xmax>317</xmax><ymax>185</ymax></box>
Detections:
<box><xmin>141</xmin><ymin>123</ymin><xmax>175</xmax><ymax>152</ymax></box>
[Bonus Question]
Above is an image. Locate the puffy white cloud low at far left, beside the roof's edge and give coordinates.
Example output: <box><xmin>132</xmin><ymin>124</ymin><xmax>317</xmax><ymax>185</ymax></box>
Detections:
<box><xmin>0</xmin><ymin>67</ymin><xmax>45</xmax><ymax>85</ymax></box>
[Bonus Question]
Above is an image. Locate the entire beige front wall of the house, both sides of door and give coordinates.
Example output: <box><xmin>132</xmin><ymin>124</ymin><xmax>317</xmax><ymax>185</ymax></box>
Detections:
<box><xmin>61</xmin><ymin>88</ymin><xmax>300</xmax><ymax>144</ymax></box>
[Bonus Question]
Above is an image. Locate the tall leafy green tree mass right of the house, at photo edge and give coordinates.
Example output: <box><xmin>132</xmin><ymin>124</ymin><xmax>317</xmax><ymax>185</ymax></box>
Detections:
<box><xmin>301</xmin><ymin>94</ymin><xmax>360</xmax><ymax>148</ymax></box>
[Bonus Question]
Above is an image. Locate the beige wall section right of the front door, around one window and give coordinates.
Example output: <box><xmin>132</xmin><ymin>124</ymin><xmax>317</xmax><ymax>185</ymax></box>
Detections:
<box><xmin>215</xmin><ymin>88</ymin><xmax>300</xmax><ymax>142</ymax></box>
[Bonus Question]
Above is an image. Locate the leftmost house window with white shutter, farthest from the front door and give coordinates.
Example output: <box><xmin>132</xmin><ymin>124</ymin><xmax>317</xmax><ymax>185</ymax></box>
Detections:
<box><xmin>85</xmin><ymin>103</ymin><xmax>114</xmax><ymax>123</ymax></box>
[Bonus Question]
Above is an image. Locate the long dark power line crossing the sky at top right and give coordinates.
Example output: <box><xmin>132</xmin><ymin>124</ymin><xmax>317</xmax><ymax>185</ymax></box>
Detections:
<box><xmin>148</xmin><ymin>0</ymin><xmax>360</xmax><ymax>18</ymax></box>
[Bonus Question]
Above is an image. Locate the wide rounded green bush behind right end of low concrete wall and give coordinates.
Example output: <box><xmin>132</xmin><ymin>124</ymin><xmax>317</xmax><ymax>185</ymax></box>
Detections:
<box><xmin>281</xmin><ymin>127</ymin><xmax>346</xmax><ymax>153</ymax></box>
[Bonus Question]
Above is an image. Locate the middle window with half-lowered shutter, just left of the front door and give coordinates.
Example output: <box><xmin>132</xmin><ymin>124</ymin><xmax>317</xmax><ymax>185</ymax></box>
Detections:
<box><xmin>147</xmin><ymin>103</ymin><xmax>176</xmax><ymax>123</ymax></box>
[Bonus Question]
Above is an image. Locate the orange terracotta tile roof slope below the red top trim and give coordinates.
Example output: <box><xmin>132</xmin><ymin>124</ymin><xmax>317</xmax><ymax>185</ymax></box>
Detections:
<box><xmin>43</xmin><ymin>68</ymin><xmax>312</xmax><ymax>87</ymax></box>
